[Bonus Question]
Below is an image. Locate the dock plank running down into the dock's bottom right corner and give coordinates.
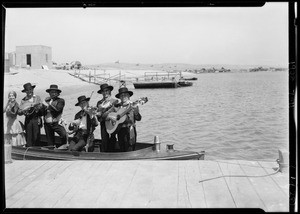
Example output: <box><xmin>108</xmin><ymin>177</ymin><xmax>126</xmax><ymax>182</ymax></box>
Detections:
<box><xmin>238</xmin><ymin>160</ymin><xmax>289</xmax><ymax>212</ymax></box>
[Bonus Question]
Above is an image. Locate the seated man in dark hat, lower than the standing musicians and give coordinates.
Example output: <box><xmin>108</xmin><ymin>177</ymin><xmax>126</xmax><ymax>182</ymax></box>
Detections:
<box><xmin>69</xmin><ymin>95</ymin><xmax>98</xmax><ymax>151</ymax></box>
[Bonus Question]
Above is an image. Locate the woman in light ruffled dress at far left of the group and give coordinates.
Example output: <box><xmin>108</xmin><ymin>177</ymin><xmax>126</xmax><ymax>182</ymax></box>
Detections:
<box><xmin>4</xmin><ymin>91</ymin><xmax>26</xmax><ymax>146</ymax></box>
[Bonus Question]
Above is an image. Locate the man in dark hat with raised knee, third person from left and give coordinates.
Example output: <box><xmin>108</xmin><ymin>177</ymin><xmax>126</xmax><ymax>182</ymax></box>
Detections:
<box><xmin>43</xmin><ymin>84</ymin><xmax>67</xmax><ymax>147</ymax></box>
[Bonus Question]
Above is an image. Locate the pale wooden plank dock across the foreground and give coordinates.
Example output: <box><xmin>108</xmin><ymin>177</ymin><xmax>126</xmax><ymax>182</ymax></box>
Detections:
<box><xmin>5</xmin><ymin>160</ymin><xmax>289</xmax><ymax>212</ymax></box>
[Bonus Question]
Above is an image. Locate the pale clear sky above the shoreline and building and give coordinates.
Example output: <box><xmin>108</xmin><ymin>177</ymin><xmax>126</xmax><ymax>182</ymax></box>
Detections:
<box><xmin>5</xmin><ymin>2</ymin><xmax>288</xmax><ymax>67</ymax></box>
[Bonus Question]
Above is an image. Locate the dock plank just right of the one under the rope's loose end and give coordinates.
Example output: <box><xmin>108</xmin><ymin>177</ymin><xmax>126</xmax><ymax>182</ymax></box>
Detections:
<box><xmin>216</xmin><ymin>160</ymin><xmax>266</xmax><ymax>210</ymax></box>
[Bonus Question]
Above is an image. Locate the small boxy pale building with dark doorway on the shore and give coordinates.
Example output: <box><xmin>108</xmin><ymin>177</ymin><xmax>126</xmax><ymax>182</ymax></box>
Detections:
<box><xmin>10</xmin><ymin>45</ymin><xmax>52</xmax><ymax>68</ymax></box>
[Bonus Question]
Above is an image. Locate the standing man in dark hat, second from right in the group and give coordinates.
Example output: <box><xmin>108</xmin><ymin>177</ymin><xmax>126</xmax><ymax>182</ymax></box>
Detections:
<box><xmin>97</xmin><ymin>83</ymin><xmax>119</xmax><ymax>152</ymax></box>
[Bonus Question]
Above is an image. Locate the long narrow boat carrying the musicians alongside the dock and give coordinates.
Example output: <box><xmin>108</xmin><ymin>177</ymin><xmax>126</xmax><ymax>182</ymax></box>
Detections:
<box><xmin>11</xmin><ymin>135</ymin><xmax>205</xmax><ymax>160</ymax></box>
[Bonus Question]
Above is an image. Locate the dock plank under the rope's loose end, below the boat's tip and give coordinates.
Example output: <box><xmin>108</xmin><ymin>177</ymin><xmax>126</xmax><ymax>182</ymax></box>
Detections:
<box><xmin>198</xmin><ymin>161</ymin><xmax>236</xmax><ymax>208</ymax></box>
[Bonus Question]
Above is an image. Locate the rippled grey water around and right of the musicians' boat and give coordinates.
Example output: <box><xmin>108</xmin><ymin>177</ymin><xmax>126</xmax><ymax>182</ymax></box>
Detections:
<box><xmin>37</xmin><ymin>72</ymin><xmax>288</xmax><ymax>160</ymax></box>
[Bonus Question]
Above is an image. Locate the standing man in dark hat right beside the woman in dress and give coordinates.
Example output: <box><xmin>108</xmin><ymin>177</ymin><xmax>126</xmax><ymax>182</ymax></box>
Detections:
<box><xmin>18</xmin><ymin>83</ymin><xmax>43</xmax><ymax>147</ymax></box>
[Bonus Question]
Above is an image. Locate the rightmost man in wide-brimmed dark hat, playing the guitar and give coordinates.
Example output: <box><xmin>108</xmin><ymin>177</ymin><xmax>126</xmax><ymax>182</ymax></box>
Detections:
<box><xmin>107</xmin><ymin>87</ymin><xmax>142</xmax><ymax>152</ymax></box>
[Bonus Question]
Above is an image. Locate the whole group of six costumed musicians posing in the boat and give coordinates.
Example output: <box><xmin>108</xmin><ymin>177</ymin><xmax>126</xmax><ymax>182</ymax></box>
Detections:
<box><xmin>4</xmin><ymin>83</ymin><xmax>148</xmax><ymax>152</ymax></box>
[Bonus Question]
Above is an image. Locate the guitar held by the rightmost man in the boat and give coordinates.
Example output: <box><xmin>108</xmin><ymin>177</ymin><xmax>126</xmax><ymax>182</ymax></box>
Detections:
<box><xmin>105</xmin><ymin>97</ymin><xmax>148</xmax><ymax>134</ymax></box>
